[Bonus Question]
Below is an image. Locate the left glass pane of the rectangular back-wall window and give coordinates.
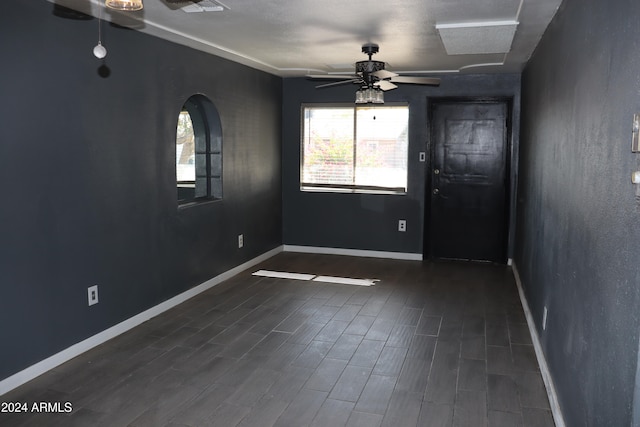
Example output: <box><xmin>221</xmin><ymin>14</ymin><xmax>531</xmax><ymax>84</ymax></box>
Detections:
<box><xmin>302</xmin><ymin>108</ymin><xmax>354</xmax><ymax>185</ymax></box>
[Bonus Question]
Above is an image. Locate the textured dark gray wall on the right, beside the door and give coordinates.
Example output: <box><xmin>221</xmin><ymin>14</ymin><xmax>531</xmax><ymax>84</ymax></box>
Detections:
<box><xmin>515</xmin><ymin>0</ymin><xmax>640</xmax><ymax>426</ymax></box>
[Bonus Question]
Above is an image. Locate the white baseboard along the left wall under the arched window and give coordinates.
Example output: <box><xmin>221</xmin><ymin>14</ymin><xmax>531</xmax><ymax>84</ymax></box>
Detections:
<box><xmin>0</xmin><ymin>246</ymin><xmax>282</xmax><ymax>396</ymax></box>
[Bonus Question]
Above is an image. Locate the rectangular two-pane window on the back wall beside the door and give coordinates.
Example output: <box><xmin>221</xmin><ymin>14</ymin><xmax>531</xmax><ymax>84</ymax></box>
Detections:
<box><xmin>300</xmin><ymin>105</ymin><xmax>409</xmax><ymax>193</ymax></box>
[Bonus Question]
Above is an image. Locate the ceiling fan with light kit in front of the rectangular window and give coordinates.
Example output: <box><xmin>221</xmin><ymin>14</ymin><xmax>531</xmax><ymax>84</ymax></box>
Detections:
<box><xmin>308</xmin><ymin>43</ymin><xmax>440</xmax><ymax>104</ymax></box>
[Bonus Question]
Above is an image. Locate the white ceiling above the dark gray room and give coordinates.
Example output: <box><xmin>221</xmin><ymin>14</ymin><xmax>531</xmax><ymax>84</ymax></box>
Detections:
<box><xmin>48</xmin><ymin>0</ymin><xmax>562</xmax><ymax>77</ymax></box>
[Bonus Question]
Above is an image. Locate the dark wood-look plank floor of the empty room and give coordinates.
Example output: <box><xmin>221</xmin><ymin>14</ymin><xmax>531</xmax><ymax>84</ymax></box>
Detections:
<box><xmin>0</xmin><ymin>253</ymin><xmax>553</xmax><ymax>427</ymax></box>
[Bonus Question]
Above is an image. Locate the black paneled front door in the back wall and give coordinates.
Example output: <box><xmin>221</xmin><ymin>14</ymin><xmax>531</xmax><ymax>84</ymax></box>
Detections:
<box><xmin>425</xmin><ymin>101</ymin><xmax>509</xmax><ymax>263</ymax></box>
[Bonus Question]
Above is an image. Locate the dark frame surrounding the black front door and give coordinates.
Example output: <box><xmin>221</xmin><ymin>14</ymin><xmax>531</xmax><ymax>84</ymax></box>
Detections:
<box><xmin>422</xmin><ymin>96</ymin><xmax>516</xmax><ymax>265</ymax></box>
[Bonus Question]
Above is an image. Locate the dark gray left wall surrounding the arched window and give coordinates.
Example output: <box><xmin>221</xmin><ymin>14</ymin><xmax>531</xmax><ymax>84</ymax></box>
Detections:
<box><xmin>0</xmin><ymin>0</ymin><xmax>282</xmax><ymax>379</ymax></box>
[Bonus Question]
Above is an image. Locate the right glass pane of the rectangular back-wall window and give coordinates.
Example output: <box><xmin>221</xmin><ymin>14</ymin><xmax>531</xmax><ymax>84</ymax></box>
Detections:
<box><xmin>355</xmin><ymin>107</ymin><xmax>409</xmax><ymax>188</ymax></box>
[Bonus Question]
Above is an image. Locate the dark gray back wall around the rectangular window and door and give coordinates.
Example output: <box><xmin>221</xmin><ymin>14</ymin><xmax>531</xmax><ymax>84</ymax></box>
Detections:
<box><xmin>282</xmin><ymin>75</ymin><xmax>520</xmax><ymax>254</ymax></box>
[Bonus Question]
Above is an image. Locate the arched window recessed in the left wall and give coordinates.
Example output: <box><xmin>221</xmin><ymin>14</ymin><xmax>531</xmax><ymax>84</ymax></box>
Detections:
<box><xmin>176</xmin><ymin>95</ymin><xmax>222</xmax><ymax>204</ymax></box>
